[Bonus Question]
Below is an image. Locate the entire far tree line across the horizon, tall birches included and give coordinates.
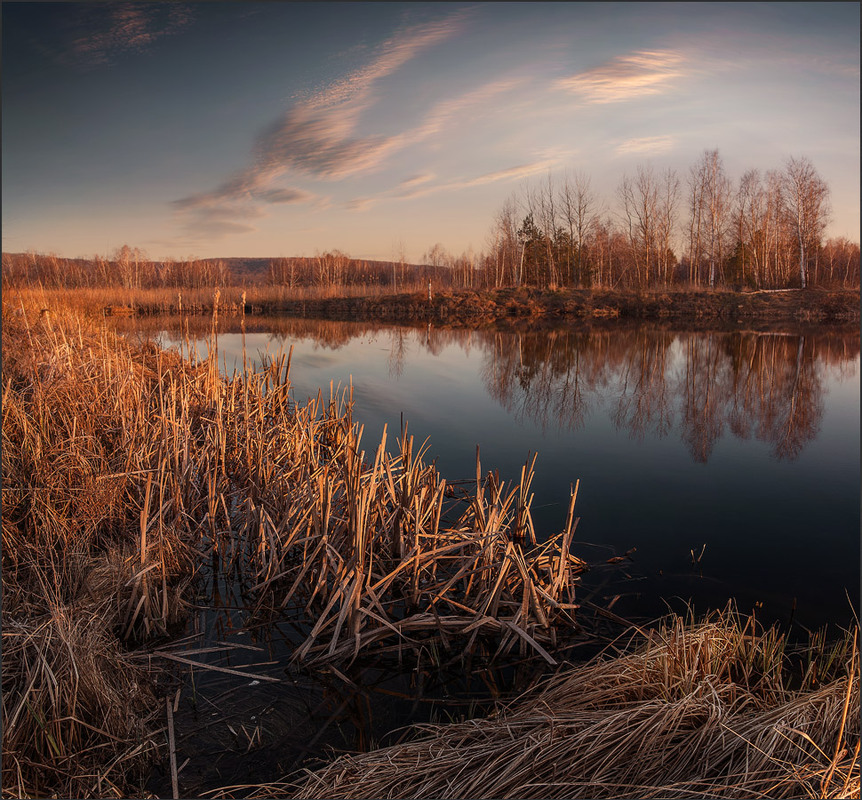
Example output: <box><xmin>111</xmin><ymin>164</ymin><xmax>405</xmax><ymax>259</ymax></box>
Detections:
<box><xmin>2</xmin><ymin>150</ymin><xmax>859</xmax><ymax>293</ymax></box>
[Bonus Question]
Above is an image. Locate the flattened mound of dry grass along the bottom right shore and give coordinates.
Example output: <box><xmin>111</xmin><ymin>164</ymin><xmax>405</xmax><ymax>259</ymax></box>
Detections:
<box><xmin>240</xmin><ymin>610</ymin><xmax>859</xmax><ymax>799</ymax></box>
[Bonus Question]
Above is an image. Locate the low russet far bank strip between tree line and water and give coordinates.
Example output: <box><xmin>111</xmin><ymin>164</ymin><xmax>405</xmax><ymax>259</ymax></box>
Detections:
<box><xmin>10</xmin><ymin>286</ymin><xmax>860</xmax><ymax>328</ymax></box>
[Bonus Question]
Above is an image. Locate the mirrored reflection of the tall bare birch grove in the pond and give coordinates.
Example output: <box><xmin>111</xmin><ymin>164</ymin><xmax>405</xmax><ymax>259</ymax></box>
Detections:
<box><xmin>482</xmin><ymin>328</ymin><xmax>859</xmax><ymax>463</ymax></box>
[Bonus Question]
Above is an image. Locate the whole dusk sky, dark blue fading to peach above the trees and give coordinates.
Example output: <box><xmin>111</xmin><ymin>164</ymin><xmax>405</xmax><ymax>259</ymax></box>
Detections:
<box><xmin>2</xmin><ymin>2</ymin><xmax>860</xmax><ymax>261</ymax></box>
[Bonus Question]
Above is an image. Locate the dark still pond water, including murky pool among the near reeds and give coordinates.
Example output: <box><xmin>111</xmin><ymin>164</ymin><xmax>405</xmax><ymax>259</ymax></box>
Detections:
<box><xmin>140</xmin><ymin>319</ymin><xmax>860</xmax><ymax>786</ymax></box>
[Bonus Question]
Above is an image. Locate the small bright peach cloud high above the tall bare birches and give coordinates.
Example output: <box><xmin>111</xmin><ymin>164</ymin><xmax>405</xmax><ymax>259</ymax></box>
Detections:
<box><xmin>556</xmin><ymin>50</ymin><xmax>686</xmax><ymax>103</ymax></box>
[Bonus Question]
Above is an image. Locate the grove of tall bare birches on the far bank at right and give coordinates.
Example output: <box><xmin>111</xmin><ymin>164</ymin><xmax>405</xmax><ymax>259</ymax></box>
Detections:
<box><xmin>485</xmin><ymin>150</ymin><xmax>859</xmax><ymax>289</ymax></box>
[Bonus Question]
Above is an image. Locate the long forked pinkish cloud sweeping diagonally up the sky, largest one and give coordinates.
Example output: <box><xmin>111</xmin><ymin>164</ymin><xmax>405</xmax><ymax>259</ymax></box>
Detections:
<box><xmin>174</xmin><ymin>10</ymin><xmax>469</xmax><ymax>239</ymax></box>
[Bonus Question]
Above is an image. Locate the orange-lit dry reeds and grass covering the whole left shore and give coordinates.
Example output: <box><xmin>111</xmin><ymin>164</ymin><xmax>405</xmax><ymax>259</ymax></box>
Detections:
<box><xmin>2</xmin><ymin>304</ymin><xmax>585</xmax><ymax>796</ymax></box>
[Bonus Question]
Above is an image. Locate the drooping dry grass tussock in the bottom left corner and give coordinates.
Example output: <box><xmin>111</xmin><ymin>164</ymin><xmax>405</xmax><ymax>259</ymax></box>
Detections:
<box><xmin>3</xmin><ymin>607</ymin><xmax>160</xmax><ymax>797</ymax></box>
